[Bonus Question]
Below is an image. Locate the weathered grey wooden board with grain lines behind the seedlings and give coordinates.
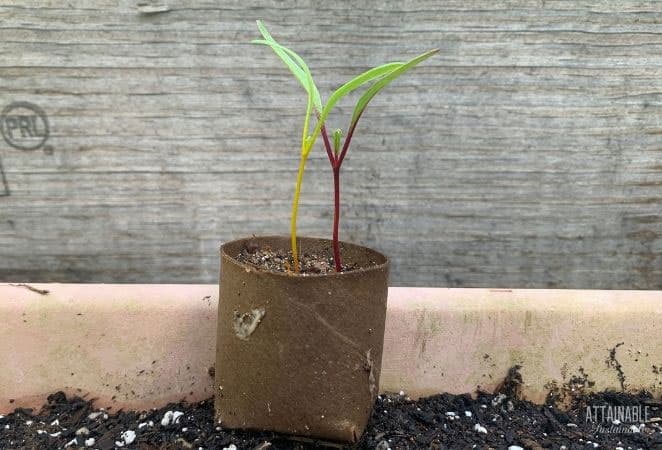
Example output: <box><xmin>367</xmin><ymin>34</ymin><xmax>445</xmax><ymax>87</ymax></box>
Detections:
<box><xmin>0</xmin><ymin>0</ymin><xmax>662</xmax><ymax>289</ymax></box>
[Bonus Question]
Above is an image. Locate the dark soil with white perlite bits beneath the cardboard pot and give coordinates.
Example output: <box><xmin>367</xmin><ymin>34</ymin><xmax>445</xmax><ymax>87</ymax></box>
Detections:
<box><xmin>0</xmin><ymin>388</ymin><xmax>662</xmax><ymax>450</ymax></box>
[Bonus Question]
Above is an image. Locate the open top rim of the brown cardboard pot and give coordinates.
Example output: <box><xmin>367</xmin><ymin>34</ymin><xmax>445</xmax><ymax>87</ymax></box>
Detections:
<box><xmin>220</xmin><ymin>234</ymin><xmax>390</xmax><ymax>279</ymax></box>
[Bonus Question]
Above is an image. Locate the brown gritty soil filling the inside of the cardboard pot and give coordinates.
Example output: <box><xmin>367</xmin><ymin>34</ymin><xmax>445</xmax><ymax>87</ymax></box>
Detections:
<box><xmin>237</xmin><ymin>245</ymin><xmax>366</xmax><ymax>275</ymax></box>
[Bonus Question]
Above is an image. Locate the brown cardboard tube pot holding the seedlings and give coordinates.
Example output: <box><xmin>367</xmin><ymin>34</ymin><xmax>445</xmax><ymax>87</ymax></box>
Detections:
<box><xmin>215</xmin><ymin>236</ymin><xmax>388</xmax><ymax>443</ymax></box>
